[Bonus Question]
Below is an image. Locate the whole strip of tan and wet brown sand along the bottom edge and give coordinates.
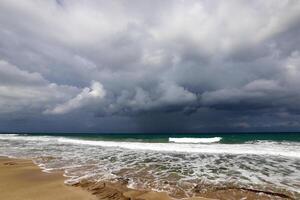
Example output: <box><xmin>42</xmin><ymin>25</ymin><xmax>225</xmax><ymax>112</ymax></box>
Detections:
<box><xmin>0</xmin><ymin>156</ymin><xmax>293</xmax><ymax>200</ymax></box>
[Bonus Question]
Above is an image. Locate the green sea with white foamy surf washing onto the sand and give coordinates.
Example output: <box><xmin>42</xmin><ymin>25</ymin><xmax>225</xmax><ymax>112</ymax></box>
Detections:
<box><xmin>0</xmin><ymin>133</ymin><xmax>300</xmax><ymax>198</ymax></box>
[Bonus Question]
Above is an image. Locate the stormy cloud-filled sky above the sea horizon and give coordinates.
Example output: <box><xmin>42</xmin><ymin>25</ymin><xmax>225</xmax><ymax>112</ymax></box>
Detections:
<box><xmin>0</xmin><ymin>0</ymin><xmax>300</xmax><ymax>133</ymax></box>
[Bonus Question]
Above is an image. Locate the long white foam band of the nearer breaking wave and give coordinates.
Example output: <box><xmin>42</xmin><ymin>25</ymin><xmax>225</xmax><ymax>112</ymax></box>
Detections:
<box><xmin>58</xmin><ymin>138</ymin><xmax>300</xmax><ymax>158</ymax></box>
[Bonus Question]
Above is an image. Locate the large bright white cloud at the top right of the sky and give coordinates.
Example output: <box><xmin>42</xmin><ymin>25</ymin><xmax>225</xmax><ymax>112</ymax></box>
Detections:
<box><xmin>151</xmin><ymin>0</ymin><xmax>300</xmax><ymax>56</ymax></box>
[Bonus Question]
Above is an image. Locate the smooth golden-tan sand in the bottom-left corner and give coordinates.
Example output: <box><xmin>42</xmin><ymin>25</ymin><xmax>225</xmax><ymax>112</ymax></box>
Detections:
<box><xmin>0</xmin><ymin>157</ymin><xmax>96</xmax><ymax>200</ymax></box>
